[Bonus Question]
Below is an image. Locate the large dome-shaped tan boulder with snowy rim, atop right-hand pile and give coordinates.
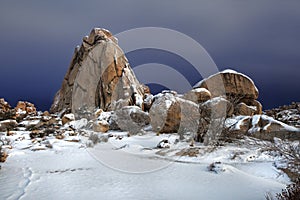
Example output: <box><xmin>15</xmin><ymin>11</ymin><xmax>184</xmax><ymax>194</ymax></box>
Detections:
<box><xmin>195</xmin><ymin>70</ymin><xmax>258</xmax><ymax>99</ymax></box>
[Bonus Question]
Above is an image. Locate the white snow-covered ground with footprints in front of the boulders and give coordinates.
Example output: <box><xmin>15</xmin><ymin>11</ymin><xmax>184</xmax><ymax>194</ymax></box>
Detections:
<box><xmin>0</xmin><ymin>131</ymin><xmax>289</xmax><ymax>200</ymax></box>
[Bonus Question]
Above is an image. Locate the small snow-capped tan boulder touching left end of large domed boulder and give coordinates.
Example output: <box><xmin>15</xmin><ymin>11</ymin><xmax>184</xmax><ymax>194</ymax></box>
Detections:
<box><xmin>183</xmin><ymin>88</ymin><xmax>211</xmax><ymax>104</ymax></box>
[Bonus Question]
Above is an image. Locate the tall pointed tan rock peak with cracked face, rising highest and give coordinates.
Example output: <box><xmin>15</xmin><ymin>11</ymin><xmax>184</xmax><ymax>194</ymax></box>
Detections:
<box><xmin>51</xmin><ymin>28</ymin><xmax>144</xmax><ymax>115</ymax></box>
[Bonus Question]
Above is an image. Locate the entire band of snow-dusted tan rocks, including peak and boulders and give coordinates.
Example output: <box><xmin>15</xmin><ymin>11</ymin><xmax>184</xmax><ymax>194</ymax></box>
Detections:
<box><xmin>0</xmin><ymin>28</ymin><xmax>300</xmax><ymax>150</ymax></box>
